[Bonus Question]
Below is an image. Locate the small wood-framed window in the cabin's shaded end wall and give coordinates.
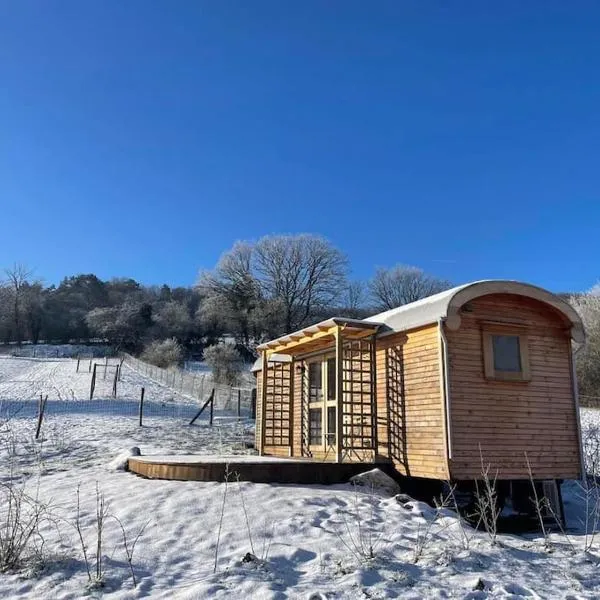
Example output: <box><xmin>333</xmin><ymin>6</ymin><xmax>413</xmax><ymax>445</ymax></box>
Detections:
<box><xmin>483</xmin><ymin>326</ymin><xmax>530</xmax><ymax>381</ymax></box>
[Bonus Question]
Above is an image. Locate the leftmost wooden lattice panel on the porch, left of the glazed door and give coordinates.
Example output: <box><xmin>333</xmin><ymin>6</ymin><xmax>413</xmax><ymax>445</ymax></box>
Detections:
<box><xmin>263</xmin><ymin>363</ymin><xmax>292</xmax><ymax>446</ymax></box>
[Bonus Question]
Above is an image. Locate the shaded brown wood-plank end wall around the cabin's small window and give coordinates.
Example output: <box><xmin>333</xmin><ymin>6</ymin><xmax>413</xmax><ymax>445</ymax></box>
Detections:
<box><xmin>446</xmin><ymin>294</ymin><xmax>580</xmax><ymax>479</ymax></box>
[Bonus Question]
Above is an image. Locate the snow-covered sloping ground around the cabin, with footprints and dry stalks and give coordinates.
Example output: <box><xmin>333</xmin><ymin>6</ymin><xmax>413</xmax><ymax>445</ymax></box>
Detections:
<box><xmin>0</xmin><ymin>359</ymin><xmax>600</xmax><ymax>600</ymax></box>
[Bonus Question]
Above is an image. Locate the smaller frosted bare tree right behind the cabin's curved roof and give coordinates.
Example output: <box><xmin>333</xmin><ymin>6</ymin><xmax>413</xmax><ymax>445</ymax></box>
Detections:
<box><xmin>369</xmin><ymin>265</ymin><xmax>451</xmax><ymax>310</ymax></box>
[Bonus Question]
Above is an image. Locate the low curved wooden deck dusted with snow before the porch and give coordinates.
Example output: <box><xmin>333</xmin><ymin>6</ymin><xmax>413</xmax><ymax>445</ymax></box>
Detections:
<box><xmin>129</xmin><ymin>455</ymin><xmax>393</xmax><ymax>484</ymax></box>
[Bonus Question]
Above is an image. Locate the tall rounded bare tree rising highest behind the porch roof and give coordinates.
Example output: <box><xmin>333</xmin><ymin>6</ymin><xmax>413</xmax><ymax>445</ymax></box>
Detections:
<box><xmin>253</xmin><ymin>234</ymin><xmax>347</xmax><ymax>332</ymax></box>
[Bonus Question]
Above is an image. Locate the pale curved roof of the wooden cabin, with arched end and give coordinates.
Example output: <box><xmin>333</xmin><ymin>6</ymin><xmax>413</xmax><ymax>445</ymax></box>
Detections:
<box><xmin>365</xmin><ymin>279</ymin><xmax>585</xmax><ymax>343</ymax></box>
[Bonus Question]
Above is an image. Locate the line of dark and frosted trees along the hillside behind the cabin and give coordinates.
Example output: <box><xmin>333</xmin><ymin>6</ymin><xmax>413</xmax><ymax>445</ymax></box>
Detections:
<box><xmin>0</xmin><ymin>234</ymin><xmax>450</xmax><ymax>357</ymax></box>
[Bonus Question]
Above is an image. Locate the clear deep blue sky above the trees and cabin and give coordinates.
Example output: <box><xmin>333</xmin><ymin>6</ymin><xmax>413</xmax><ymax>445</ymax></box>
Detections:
<box><xmin>0</xmin><ymin>0</ymin><xmax>600</xmax><ymax>291</ymax></box>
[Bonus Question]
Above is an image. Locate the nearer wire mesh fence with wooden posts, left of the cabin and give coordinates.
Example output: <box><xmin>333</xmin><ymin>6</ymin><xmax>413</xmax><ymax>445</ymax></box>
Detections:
<box><xmin>0</xmin><ymin>397</ymin><xmax>254</xmax><ymax>460</ymax></box>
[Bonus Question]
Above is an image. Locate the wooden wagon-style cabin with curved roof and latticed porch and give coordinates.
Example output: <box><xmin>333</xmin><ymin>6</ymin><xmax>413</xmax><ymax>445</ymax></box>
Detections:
<box><xmin>255</xmin><ymin>281</ymin><xmax>584</xmax><ymax>492</ymax></box>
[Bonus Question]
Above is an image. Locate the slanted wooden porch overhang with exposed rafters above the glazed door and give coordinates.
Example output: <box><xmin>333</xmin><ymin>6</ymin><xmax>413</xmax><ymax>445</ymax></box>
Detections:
<box><xmin>257</xmin><ymin>317</ymin><xmax>382</xmax><ymax>357</ymax></box>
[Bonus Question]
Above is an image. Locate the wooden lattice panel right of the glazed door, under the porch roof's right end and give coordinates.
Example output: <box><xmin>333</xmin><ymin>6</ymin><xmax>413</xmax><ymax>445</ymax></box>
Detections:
<box><xmin>342</xmin><ymin>340</ymin><xmax>376</xmax><ymax>460</ymax></box>
